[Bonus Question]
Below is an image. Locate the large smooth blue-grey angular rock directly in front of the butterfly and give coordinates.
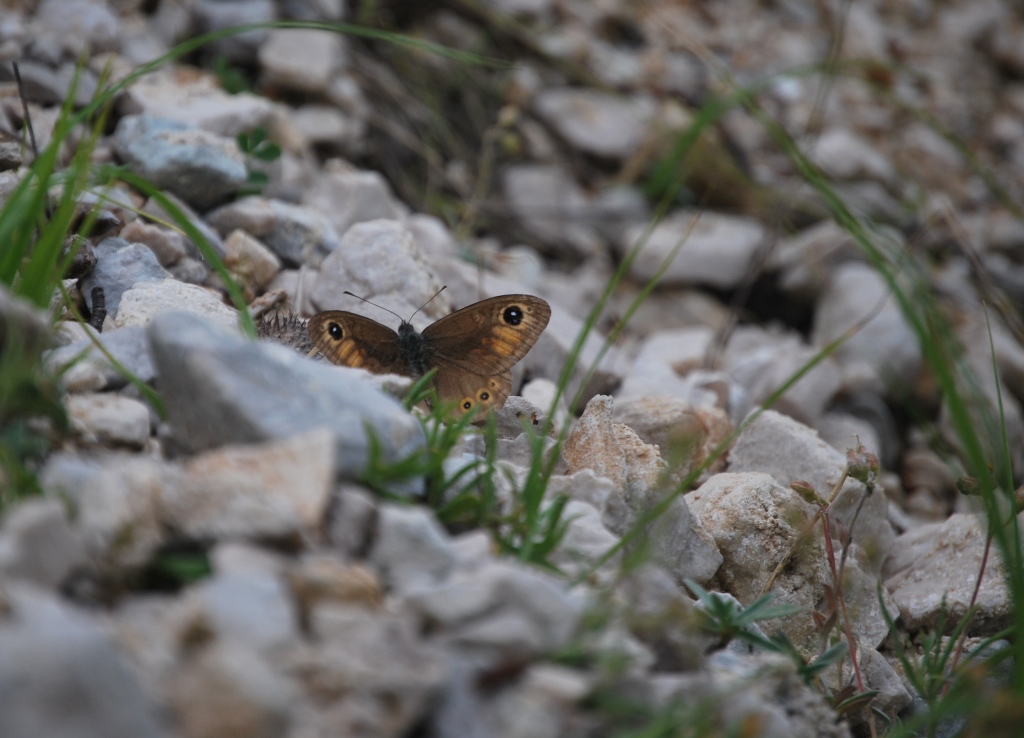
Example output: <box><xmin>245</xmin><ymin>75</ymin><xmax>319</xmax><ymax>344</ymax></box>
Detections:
<box><xmin>148</xmin><ymin>313</ymin><xmax>424</xmax><ymax>477</ymax></box>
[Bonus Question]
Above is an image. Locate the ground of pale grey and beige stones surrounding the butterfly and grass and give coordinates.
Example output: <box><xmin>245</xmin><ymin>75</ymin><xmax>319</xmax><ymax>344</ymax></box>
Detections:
<box><xmin>0</xmin><ymin>0</ymin><xmax>1024</xmax><ymax>738</ymax></box>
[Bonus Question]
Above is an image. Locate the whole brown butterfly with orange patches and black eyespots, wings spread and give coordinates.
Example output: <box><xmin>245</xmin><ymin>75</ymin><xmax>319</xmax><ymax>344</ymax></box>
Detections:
<box><xmin>306</xmin><ymin>295</ymin><xmax>551</xmax><ymax>413</ymax></box>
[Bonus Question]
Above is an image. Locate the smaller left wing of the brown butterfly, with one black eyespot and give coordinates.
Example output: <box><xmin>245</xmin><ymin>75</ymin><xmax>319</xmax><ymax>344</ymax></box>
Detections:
<box><xmin>306</xmin><ymin>310</ymin><xmax>408</xmax><ymax>375</ymax></box>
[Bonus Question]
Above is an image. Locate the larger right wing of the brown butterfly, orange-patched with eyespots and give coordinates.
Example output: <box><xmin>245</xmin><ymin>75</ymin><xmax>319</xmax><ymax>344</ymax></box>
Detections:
<box><xmin>423</xmin><ymin>295</ymin><xmax>551</xmax><ymax>413</ymax></box>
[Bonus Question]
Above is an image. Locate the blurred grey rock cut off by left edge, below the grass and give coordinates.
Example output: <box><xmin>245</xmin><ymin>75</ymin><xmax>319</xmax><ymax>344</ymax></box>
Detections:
<box><xmin>0</xmin><ymin>500</ymin><xmax>85</xmax><ymax>589</ymax></box>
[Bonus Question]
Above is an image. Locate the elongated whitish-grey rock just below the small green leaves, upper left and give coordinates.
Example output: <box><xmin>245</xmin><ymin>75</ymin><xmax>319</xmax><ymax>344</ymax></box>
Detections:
<box><xmin>207</xmin><ymin>198</ymin><xmax>339</xmax><ymax>266</ymax></box>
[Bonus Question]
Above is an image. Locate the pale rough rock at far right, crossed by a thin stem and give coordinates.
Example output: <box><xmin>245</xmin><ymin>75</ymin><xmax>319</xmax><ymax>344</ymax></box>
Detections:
<box><xmin>883</xmin><ymin>514</ymin><xmax>1013</xmax><ymax>635</ymax></box>
